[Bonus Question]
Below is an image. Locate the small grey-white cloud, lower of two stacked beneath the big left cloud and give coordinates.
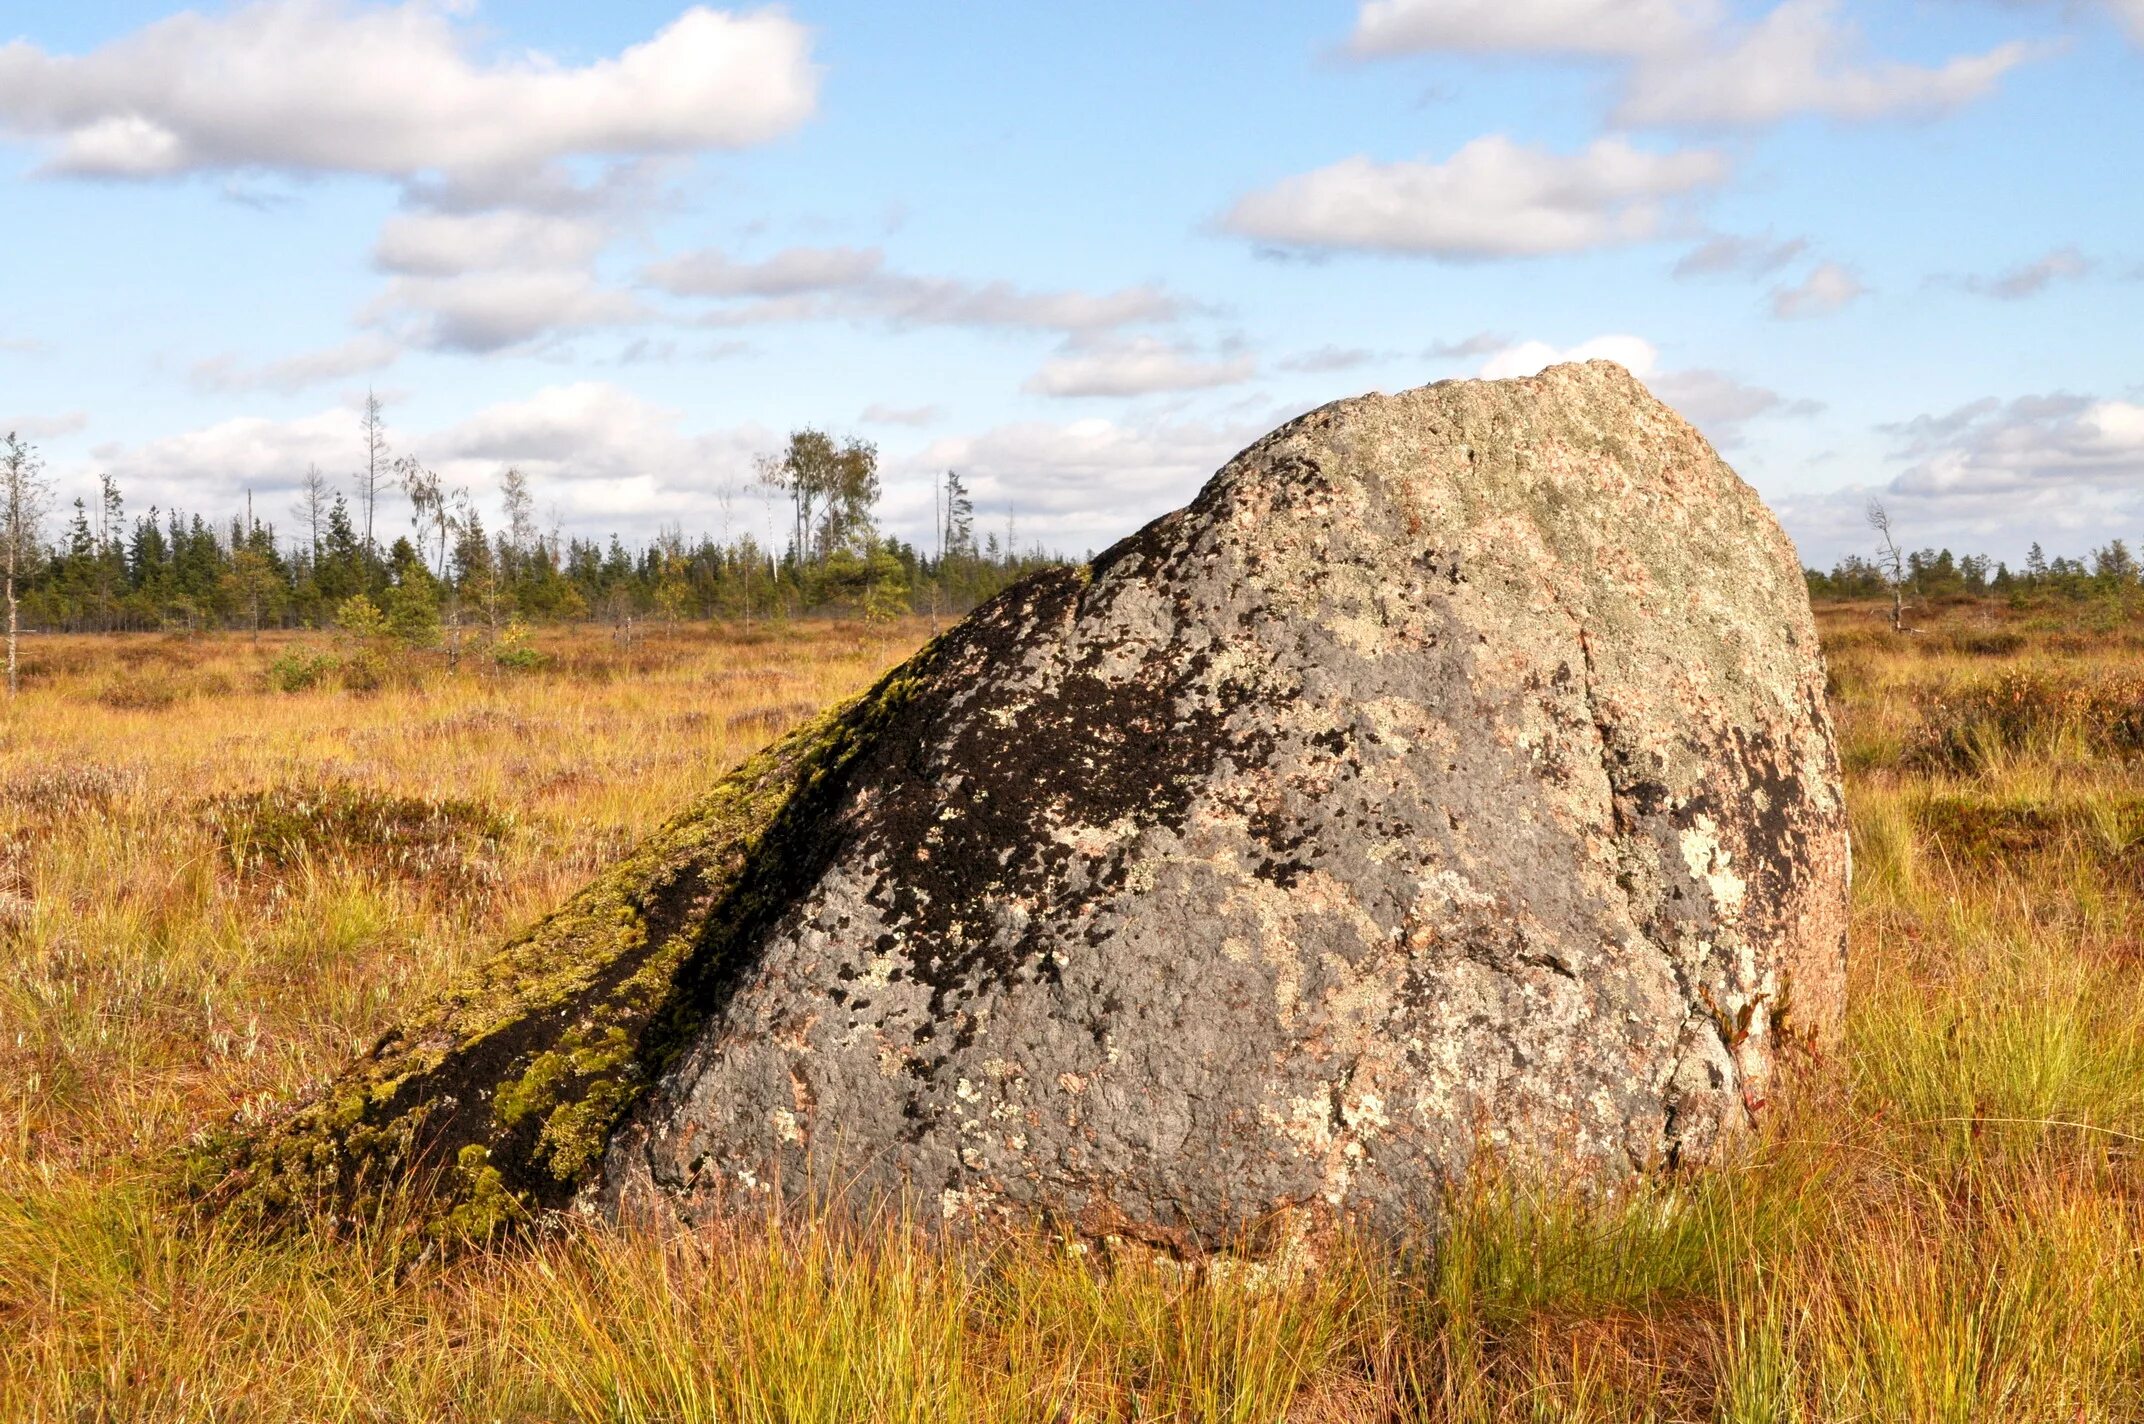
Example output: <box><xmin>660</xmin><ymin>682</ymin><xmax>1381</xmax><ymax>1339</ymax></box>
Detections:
<box><xmin>360</xmin><ymin>270</ymin><xmax>650</xmax><ymax>354</ymax></box>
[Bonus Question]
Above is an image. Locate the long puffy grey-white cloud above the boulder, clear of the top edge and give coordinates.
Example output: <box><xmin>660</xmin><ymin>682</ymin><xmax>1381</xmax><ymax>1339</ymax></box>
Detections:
<box><xmin>1224</xmin><ymin>135</ymin><xmax>1728</xmax><ymax>259</ymax></box>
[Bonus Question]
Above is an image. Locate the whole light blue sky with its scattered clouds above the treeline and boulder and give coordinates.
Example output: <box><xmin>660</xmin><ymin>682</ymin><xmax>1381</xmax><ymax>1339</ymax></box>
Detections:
<box><xmin>0</xmin><ymin>0</ymin><xmax>2144</xmax><ymax>564</ymax></box>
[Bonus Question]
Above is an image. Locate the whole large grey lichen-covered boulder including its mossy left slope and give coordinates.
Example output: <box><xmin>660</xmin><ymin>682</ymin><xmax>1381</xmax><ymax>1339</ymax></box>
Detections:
<box><xmin>209</xmin><ymin>362</ymin><xmax>1848</xmax><ymax>1246</ymax></box>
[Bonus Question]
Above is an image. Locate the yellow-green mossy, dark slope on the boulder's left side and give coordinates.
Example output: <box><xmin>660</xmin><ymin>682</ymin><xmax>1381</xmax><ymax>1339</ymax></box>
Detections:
<box><xmin>184</xmin><ymin>648</ymin><xmax>935</xmax><ymax>1244</ymax></box>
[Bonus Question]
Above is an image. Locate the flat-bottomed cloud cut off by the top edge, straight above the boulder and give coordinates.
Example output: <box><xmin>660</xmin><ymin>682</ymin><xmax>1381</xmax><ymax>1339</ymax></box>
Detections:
<box><xmin>1349</xmin><ymin>0</ymin><xmax>1717</xmax><ymax>58</ymax></box>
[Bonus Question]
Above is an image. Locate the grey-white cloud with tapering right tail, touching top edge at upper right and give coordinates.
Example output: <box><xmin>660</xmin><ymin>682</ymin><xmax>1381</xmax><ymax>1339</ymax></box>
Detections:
<box><xmin>1614</xmin><ymin>0</ymin><xmax>2035</xmax><ymax>127</ymax></box>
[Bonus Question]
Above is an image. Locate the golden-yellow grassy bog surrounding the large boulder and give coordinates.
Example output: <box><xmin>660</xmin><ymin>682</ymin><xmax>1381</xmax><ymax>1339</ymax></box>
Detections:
<box><xmin>0</xmin><ymin>605</ymin><xmax>2144</xmax><ymax>1424</ymax></box>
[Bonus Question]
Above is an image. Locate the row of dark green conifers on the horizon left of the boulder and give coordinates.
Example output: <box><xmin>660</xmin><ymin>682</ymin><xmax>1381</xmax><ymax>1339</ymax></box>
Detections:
<box><xmin>0</xmin><ymin>418</ymin><xmax>1059</xmax><ymax>641</ymax></box>
